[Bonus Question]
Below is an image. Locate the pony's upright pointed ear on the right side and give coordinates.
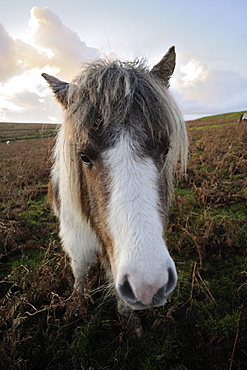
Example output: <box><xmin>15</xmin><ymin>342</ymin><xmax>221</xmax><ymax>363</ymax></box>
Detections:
<box><xmin>151</xmin><ymin>46</ymin><xmax>176</xmax><ymax>87</ymax></box>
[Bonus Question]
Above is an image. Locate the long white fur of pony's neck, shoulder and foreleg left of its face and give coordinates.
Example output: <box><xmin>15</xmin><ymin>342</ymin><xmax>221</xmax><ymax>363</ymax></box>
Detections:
<box><xmin>52</xmin><ymin>126</ymin><xmax>101</xmax><ymax>292</ymax></box>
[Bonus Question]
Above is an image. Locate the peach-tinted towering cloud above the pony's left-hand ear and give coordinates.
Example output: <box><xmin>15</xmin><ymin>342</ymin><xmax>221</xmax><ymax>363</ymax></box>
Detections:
<box><xmin>0</xmin><ymin>7</ymin><xmax>100</xmax><ymax>83</ymax></box>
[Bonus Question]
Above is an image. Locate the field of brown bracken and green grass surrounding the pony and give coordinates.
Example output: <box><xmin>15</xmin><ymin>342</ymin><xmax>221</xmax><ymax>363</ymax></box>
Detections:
<box><xmin>0</xmin><ymin>114</ymin><xmax>247</xmax><ymax>370</ymax></box>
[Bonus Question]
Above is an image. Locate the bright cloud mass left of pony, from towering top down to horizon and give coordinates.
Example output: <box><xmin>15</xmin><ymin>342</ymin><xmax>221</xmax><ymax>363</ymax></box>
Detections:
<box><xmin>0</xmin><ymin>7</ymin><xmax>100</xmax><ymax>122</ymax></box>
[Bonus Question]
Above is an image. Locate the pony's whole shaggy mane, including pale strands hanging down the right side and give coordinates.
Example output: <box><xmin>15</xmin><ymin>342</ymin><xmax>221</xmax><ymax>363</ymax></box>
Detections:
<box><xmin>58</xmin><ymin>60</ymin><xmax>188</xmax><ymax>202</ymax></box>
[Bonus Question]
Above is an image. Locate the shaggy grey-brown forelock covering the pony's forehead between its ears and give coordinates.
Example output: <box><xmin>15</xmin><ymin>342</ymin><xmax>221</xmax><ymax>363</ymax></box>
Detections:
<box><xmin>67</xmin><ymin>62</ymin><xmax>172</xmax><ymax>147</ymax></box>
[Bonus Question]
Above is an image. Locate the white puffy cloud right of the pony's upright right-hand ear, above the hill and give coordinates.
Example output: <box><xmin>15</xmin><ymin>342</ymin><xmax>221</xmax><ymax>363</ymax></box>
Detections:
<box><xmin>172</xmin><ymin>54</ymin><xmax>247</xmax><ymax>115</ymax></box>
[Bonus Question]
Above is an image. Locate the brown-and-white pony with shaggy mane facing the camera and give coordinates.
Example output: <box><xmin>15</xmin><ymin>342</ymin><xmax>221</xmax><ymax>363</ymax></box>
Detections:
<box><xmin>42</xmin><ymin>47</ymin><xmax>188</xmax><ymax>312</ymax></box>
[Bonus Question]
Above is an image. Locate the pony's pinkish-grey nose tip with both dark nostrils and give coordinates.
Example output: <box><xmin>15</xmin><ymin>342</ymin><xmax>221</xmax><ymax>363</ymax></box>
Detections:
<box><xmin>117</xmin><ymin>268</ymin><xmax>177</xmax><ymax>310</ymax></box>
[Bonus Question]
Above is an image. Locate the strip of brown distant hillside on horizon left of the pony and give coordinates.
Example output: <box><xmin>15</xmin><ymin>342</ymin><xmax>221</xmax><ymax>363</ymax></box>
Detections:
<box><xmin>0</xmin><ymin>122</ymin><xmax>59</xmax><ymax>141</ymax></box>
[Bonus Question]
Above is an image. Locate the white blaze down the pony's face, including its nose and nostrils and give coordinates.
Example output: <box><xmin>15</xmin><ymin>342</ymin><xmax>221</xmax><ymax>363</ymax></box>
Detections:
<box><xmin>105</xmin><ymin>133</ymin><xmax>177</xmax><ymax>309</ymax></box>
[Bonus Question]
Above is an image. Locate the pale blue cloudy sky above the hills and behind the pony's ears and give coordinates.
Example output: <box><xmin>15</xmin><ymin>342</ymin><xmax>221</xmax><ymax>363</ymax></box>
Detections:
<box><xmin>0</xmin><ymin>0</ymin><xmax>247</xmax><ymax>123</ymax></box>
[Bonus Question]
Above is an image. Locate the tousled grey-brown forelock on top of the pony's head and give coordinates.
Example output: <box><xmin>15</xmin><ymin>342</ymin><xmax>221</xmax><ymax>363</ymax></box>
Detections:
<box><xmin>68</xmin><ymin>60</ymin><xmax>178</xmax><ymax>136</ymax></box>
